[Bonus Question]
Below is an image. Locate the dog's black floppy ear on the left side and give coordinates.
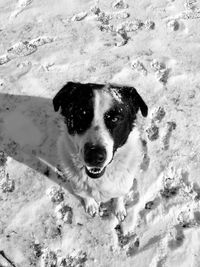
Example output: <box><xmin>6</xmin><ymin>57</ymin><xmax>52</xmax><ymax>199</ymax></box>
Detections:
<box><xmin>53</xmin><ymin>82</ymin><xmax>78</xmax><ymax>111</ymax></box>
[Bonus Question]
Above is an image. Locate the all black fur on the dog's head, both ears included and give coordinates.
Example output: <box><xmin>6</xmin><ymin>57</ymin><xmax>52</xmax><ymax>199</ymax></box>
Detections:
<box><xmin>53</xmin><ymin>82</ymin><xmax>148</xmax><ymax>143</ymax></box>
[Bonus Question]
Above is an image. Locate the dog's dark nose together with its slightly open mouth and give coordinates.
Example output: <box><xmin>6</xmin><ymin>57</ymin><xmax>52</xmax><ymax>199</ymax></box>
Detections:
<box><xmin>84</xmin><ymin>143</ymin><xmax>107</xmax><ymax>179</ymax></box>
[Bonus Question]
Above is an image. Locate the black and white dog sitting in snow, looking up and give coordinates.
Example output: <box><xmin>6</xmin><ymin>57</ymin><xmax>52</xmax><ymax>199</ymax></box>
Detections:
<box><xmin>53</xmin><ymin>82</ymin><xmax>148</xmax><ymax>221</ymax></box>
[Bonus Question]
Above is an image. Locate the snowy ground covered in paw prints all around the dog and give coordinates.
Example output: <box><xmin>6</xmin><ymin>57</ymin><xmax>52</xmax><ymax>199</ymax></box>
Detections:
<box><xmin>0</xmin><ymin>0</ymin><xmax>200</xmax><ymax>267</ymax></box>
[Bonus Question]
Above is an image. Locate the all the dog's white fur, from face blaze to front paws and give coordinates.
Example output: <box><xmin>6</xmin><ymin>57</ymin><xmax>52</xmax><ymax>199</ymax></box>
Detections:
<box><xmin>58</xmin><ymin>91</ymin><xmax>143</xmax><ymax>220</ymax></box>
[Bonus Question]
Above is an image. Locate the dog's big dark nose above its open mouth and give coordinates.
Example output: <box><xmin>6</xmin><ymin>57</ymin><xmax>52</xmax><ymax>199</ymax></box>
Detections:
<box><xmin>84</xmin><ymin>143</ymin><xmax>106</xmax><ymax>167</ymax></box>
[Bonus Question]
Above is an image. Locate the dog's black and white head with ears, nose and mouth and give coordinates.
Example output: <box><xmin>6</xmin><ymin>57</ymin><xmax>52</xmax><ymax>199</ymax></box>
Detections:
<box><xmin>53</xmin><ymin>82</ymin><xmax>148</xmax><ymax>178</ymax></box>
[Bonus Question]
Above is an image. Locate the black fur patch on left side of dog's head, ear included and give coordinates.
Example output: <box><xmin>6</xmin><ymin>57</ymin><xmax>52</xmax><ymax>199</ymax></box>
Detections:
<box><xmin>53</xmin><ymin>82</ymin><xmax>104</xmax><ymax>135</ymax></box>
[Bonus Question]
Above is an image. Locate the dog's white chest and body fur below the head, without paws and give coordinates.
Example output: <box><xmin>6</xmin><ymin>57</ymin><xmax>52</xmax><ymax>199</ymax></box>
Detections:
<box><xmin>58</xmin><ymin>125</ymin><xmax>143</xmax><ymax>209</ymax></box>
